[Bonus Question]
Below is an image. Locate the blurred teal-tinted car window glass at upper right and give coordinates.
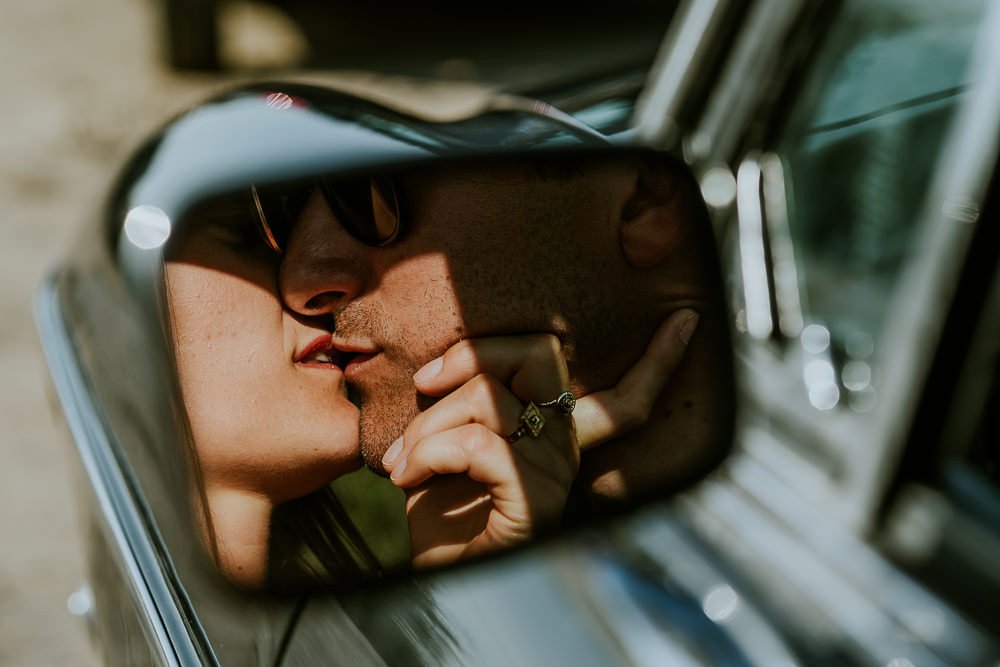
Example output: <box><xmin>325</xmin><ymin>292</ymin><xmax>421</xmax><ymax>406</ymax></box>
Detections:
<box><xmin>776</xmin><ymin>0</ymin><xmax>983</xmax><ymax>413</ymax></box>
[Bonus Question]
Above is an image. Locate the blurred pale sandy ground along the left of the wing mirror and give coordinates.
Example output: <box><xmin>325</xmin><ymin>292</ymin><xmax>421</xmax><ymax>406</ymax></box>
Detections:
<box><xmin>0</xmin><ymin>0</ymin><xmax>219</xmax><ymax>665</ymax></box>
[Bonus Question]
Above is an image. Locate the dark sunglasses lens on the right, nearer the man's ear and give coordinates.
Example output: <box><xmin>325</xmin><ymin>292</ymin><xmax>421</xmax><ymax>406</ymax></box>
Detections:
<box><xmin>320</xmin><ymin>176</ymin><xmax>400</xmax><ymax>245</ymax></box>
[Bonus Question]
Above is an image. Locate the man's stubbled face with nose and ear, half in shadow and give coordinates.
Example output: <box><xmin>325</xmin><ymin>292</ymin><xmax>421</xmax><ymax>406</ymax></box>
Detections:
<box><xmin>280</xmin><ymin>160</ymin><xmax>652</xmax><ymax>470</ymax></box>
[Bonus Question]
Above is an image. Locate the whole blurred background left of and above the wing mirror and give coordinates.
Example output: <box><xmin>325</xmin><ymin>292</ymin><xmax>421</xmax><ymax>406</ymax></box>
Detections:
<box><xmin>0</xmin><ymin>0</ymin><xmax>670</xmax><ymax>665</ymax></box>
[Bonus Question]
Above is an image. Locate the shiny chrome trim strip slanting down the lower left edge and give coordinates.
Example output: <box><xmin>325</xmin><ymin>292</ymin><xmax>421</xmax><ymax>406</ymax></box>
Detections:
<box><xmin>34</xmin><ymin>275</ymin><xmax>218</xmax><ymax>666</ymax></box>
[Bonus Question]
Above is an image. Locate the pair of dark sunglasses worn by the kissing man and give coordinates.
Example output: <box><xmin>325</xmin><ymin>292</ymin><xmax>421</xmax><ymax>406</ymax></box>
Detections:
<box><xmin>250</xmin><ymin>175</ymin><xmax>402</xmax><ymax>255</ymax></box>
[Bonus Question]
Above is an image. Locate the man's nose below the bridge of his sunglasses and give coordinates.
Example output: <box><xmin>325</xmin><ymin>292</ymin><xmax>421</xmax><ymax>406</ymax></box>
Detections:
<box><xmin>279</xmin><ymin>192</ymin><xmax>368</xmax><ymax>316</ymax></box>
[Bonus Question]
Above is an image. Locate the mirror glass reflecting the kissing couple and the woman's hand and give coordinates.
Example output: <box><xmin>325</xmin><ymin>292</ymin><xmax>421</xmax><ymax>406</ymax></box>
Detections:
<box><xmin>158</xmin><ymin>151</ymin><xmax>732</xmax><ymax>589</ymax></box>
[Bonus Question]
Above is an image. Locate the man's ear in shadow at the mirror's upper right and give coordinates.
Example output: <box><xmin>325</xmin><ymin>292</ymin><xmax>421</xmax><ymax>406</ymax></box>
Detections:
<box><xmin>620</xmin><ymin>164</ymin><xmax>685</xmax><ymax>269</ymax></box>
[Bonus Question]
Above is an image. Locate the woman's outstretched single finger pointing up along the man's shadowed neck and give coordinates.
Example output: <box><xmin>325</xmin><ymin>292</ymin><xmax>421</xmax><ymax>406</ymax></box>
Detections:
<box><xmin>573</xmin><ymin>308</ymin><xmax>698</xmax><ymax>450</ymax></box>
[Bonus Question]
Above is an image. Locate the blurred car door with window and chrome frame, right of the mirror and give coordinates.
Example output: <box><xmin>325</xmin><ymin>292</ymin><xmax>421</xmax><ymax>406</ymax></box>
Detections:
<box><xmin>639</xmin><ymin>1</ymin><xmax>998</xmax><ymax>664</ymax></box>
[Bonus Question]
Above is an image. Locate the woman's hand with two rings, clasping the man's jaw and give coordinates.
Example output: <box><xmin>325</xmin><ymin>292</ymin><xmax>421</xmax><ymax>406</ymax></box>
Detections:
<box><xmin>383</xmin><ymin>310</ymin><xmax>697</xmax><ymax>567</ymax></box>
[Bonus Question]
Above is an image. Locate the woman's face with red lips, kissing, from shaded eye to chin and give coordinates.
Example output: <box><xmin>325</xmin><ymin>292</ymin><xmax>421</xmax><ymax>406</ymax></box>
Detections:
<box><xmin>165</xmin><ymin>201</ymin><xmax>361</xmax><ymax>503</ymax></box>
